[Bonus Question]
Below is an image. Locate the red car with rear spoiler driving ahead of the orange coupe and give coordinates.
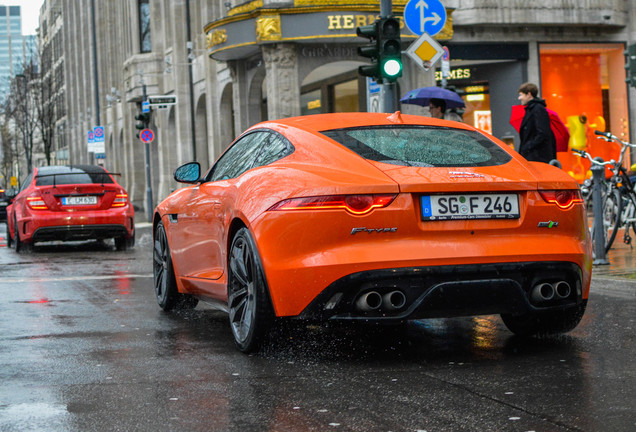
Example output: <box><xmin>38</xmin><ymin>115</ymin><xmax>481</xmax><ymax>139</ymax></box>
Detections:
<box><xmin>7</xmin><ymin>165</ymin><xmax>135</xmax><ymax>252</ymax></box>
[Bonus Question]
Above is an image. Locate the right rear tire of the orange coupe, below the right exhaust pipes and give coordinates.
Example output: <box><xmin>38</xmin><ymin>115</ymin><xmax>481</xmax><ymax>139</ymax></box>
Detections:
<box><xmin>501</xmin><ymin>300</ymin><xmax>587</xmax><ymax>336</ymax></box>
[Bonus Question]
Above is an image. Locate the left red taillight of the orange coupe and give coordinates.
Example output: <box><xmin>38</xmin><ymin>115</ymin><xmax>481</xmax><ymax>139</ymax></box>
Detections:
<box><xmin>269</xmin><ymin>194</ymin><xmax>397</xmax><ymax>215</ymax></box>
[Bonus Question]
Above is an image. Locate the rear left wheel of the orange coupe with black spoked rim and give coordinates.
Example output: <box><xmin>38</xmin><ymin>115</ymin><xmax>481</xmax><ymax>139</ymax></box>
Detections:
<box><xmin>228</xmin><ymin>228</ymin><xmax>274</xmax><ymax>353</ymax></box>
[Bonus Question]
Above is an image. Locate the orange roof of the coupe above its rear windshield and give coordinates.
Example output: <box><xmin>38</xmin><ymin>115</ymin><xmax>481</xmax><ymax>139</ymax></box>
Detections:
<box><xmin>254</xmin><ymin>111</ymin><xmax>475</xmax><ymax>132</ymax></box>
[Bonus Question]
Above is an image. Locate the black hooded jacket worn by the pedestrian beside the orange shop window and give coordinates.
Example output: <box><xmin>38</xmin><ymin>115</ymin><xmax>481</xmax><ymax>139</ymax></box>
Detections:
<box><xmin>519</xmin><ymin>97</ymin><xmax>556</xmax><ymax>163</ymax></box>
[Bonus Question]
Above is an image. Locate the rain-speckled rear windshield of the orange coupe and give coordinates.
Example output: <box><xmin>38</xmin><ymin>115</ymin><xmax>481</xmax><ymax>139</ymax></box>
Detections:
<box><xmin>321</xmin><ymin>126</ymin><xmax>512</xmax><ymax>167</ymax></box>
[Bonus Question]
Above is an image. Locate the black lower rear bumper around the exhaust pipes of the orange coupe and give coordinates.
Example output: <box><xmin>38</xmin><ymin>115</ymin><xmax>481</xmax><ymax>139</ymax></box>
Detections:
<box><xmin>298</xmin><ymin>262</ymin><xmax>583</xmax><ymax>320</ymax></box>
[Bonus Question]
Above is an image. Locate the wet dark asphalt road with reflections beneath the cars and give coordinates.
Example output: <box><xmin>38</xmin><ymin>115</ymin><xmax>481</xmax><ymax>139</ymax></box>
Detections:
<box><xmin>0</xmin><ymin>224</ymin><xmax>636</xmax><ymax>432</ymax></box>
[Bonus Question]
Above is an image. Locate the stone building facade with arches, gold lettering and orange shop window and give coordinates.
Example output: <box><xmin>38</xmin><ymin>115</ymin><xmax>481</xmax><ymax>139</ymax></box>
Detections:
<box><xmin>41</xmin><ymin>0</ymin><xmax>636</xmax><ymax>216</ymax></box>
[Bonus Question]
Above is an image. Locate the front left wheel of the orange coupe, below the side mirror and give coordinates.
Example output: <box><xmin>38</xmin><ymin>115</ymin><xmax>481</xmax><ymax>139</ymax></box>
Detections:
<box><xmin>152</xmin><ymin>222</ymin><xmax>199</xmax><ymax>311</ymax></box>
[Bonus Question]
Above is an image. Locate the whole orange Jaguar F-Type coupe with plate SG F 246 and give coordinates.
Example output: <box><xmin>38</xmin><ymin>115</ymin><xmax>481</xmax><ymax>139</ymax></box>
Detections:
<box><xmin>153</xmin><ymin>112</ymin><xmax>592</xmax><ymax>352</ymax></box>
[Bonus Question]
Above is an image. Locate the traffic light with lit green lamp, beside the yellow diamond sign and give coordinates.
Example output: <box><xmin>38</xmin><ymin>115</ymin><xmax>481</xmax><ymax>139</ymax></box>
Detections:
<box><xmin>378</xmin><ymin>17</ymin><xmax>402</xmax><ymax>82</ymax></box>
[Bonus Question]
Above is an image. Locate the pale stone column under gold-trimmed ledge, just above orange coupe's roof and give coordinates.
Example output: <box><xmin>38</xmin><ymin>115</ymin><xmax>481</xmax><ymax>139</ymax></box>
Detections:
<box><xmin>262</xmin><ymin>44</ymin><xmax>300</xmax><ymax>120</ymax></box>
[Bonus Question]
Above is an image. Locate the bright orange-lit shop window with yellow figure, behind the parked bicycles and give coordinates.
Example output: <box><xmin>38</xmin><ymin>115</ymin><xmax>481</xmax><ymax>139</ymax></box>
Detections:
<box><xmin>540</xmin><ymin>44</ymin><xmax>629</xmax><ymax>181</ymax></box>
